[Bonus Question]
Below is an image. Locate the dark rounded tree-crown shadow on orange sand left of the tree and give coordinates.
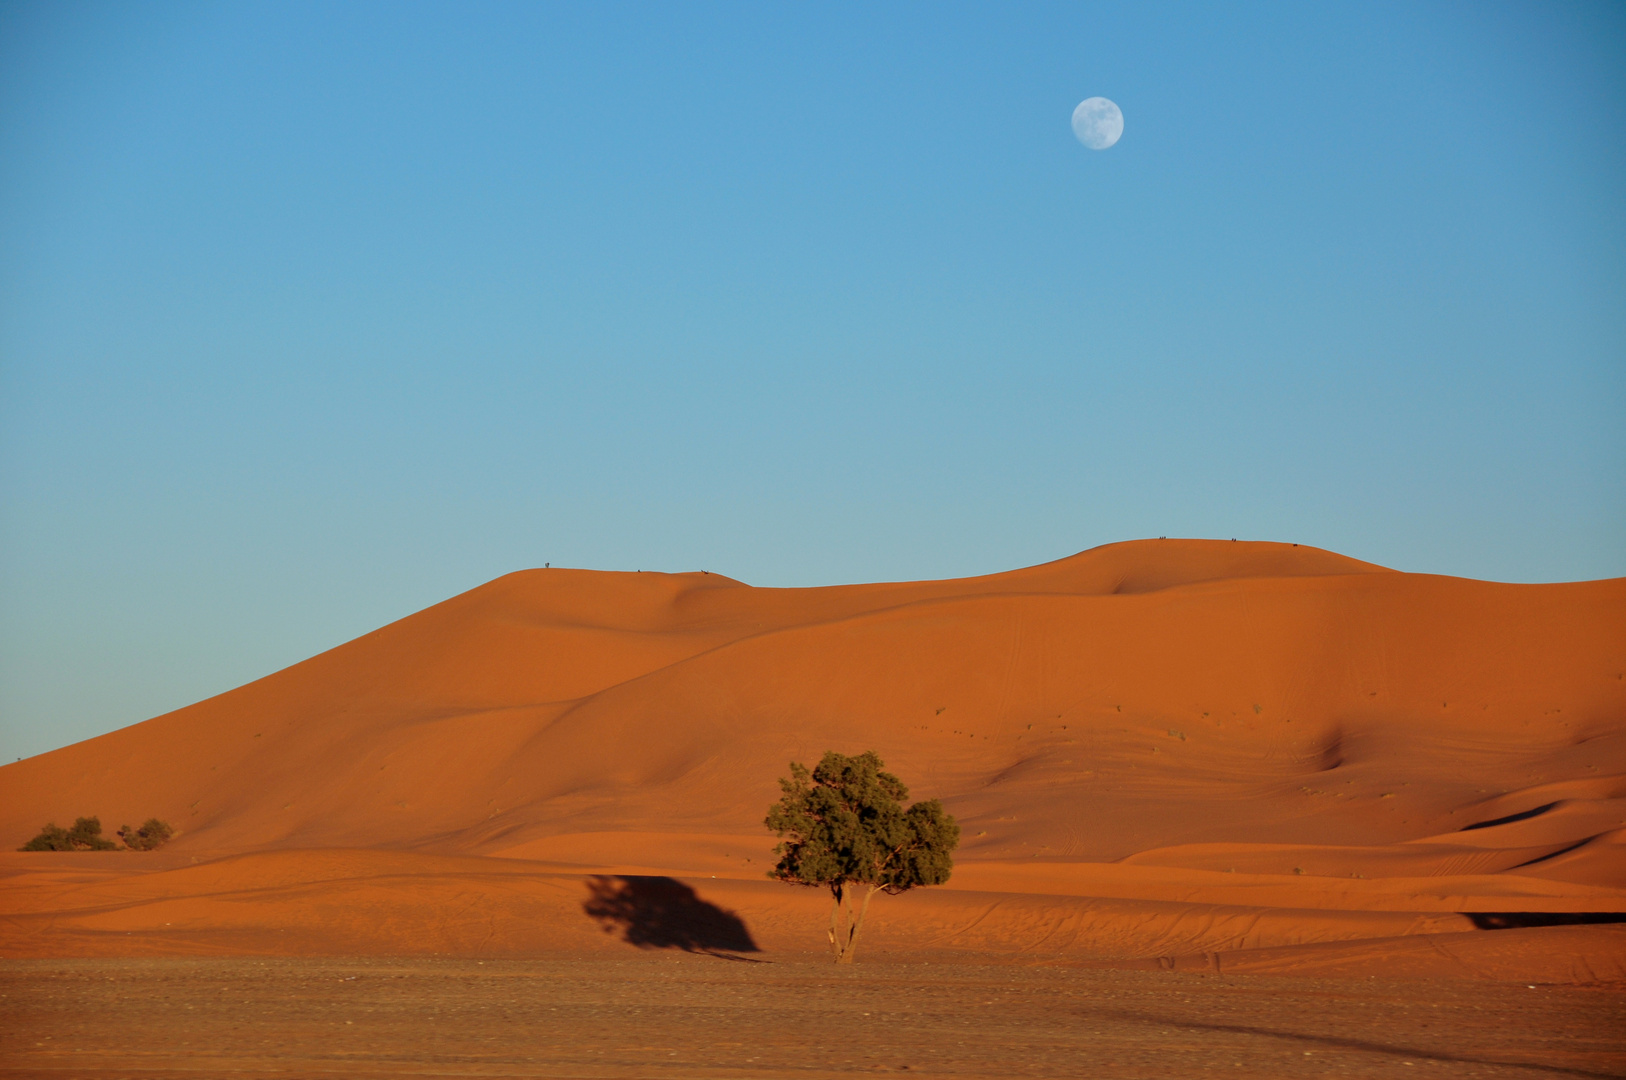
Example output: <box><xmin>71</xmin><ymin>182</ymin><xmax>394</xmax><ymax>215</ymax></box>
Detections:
<box><xmin>582</xmin><ymin>875</ymin><xmax>761</xmax><ymax>960</ymax></box>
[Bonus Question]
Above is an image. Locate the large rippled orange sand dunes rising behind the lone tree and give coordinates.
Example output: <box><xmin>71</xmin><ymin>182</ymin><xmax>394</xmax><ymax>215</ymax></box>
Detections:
<box><xmin>0</xmin><ymin>540</ymin><xmax>1626</xmax><ymax>978</ymax></box>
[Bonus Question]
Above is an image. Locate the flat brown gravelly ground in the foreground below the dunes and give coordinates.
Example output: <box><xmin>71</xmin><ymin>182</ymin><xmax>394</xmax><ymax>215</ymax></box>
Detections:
<box><xmin>0</xmin><ymin>953</ymin><xmax>1626</xmax><ymax>1080</ymax></box>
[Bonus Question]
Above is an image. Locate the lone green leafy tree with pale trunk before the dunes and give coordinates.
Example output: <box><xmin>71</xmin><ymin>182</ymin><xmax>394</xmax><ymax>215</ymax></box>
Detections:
<box><xmin>767</xmin><ymin>750</ymin><xmax>959</xmax><ymax>965</ymax></box>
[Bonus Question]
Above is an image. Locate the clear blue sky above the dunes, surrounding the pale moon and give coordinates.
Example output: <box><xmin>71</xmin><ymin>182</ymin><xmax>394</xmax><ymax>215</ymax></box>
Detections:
<box><xmin>0</xmin><ymin>3</ymin><xmax>1626</xmax><ymax>756</ymax></box>
